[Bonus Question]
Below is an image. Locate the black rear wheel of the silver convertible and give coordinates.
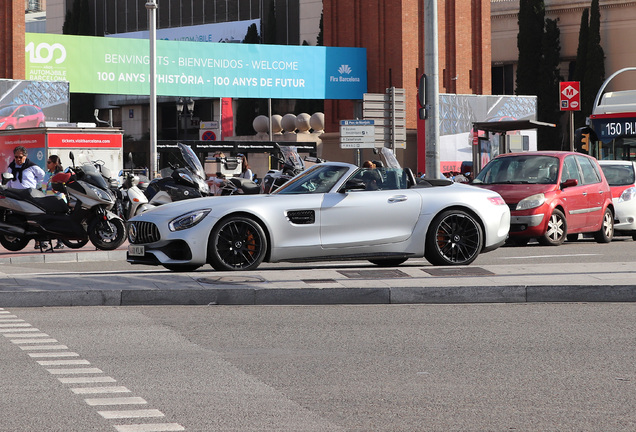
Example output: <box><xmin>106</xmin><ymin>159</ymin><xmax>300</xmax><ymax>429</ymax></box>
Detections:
<box><xmin>424</xmin><ymin>210</ymin><xmax>484</xmax><ymax>265</ymax></box>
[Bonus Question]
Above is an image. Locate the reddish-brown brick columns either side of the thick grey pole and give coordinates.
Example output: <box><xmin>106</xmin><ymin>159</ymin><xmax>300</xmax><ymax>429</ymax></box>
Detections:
<box><xmin>323</xmin><ymin>0</ymin><xmax>491</xmax><ymax>132</ymax></box>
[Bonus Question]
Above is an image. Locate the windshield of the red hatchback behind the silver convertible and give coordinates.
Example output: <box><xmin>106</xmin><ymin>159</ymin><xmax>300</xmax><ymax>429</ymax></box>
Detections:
<box><xmin>473</xmin><ymin>154</ymin><xmax>559</xmax><ymax>184</ymax></box>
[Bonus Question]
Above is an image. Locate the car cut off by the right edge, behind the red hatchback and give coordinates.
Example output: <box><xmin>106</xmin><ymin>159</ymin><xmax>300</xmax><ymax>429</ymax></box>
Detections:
<box><xmin>599</xmin><ymin>160</ymin><xmax>636</xmax><ymax>240</ymax></box>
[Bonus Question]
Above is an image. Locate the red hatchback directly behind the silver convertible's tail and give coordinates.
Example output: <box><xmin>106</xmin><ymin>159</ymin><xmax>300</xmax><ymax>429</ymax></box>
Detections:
<box><xmin>472</xmin><ymin>151</ymin><xmax>614</xmax><ymax>246</ymax></box>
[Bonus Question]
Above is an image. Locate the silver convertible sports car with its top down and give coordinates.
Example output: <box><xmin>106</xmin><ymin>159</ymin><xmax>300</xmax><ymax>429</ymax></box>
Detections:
<box><xmin>127</xmin><ymin>162</ymin><xmax>510</xmax><ymax>271</ymax></box>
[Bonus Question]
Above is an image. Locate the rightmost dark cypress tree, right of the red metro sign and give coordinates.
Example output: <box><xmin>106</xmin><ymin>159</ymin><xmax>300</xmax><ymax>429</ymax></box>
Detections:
<box><xmin>581</xmin><ymin>0</ymin><xmax>605</xmax><ymax>123</ymax></box>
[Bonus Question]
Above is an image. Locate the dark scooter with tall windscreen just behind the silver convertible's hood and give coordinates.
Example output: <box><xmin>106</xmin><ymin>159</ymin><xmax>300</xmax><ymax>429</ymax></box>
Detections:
<box><xmin>145</xmin><ymin>143</ymin><xmax>210</xmax><ymax>206</ymax></box>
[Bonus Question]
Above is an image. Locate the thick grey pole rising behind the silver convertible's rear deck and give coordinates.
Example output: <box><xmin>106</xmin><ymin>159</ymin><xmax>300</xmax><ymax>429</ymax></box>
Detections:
<box><xmin>424</xmin><ymin>0</ymin><xmax>440</xmax><ymax>178</ymax></box>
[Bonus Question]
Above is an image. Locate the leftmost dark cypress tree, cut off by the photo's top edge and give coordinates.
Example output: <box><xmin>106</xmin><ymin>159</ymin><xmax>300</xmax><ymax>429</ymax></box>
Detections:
<box><xmin>516</xmin><ymin>0</ymin><xmax>545</xmax><ymax>95</ymax></box>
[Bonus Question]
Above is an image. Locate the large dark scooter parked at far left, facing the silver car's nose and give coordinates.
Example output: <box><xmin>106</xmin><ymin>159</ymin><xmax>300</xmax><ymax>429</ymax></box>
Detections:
<box><xmin>0</xmin><ymin>152</ymin><xmax>126</xmax><ymax>252</ymax></box>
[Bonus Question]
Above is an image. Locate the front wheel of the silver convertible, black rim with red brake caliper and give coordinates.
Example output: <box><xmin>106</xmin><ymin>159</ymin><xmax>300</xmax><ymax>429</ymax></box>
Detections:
<box><xmin>208</xmin><ymin>216</ymin><xmax>267</xmax><ymax>271</ymax></box>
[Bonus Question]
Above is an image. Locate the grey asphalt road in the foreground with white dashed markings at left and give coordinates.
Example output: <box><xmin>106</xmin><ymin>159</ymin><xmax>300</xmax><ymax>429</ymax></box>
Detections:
<box><xmin>0</xmin><ymin>303</ymin><xmax>636</xmax><ymax>432</ymax></box>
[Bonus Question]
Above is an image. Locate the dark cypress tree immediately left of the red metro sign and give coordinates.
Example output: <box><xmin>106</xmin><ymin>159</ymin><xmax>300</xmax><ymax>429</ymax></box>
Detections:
<box><xmin>537</xmin><ymin>19</ymin><xmax>563</xmax><ymax>150</ymax></box>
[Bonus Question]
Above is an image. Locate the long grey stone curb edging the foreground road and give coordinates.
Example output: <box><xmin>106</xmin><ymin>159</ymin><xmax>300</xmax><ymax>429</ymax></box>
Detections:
<box><xmin>0</xmin><ymin>285</ymin><xmax>636</xmax><ymax>307</ymax></box>
